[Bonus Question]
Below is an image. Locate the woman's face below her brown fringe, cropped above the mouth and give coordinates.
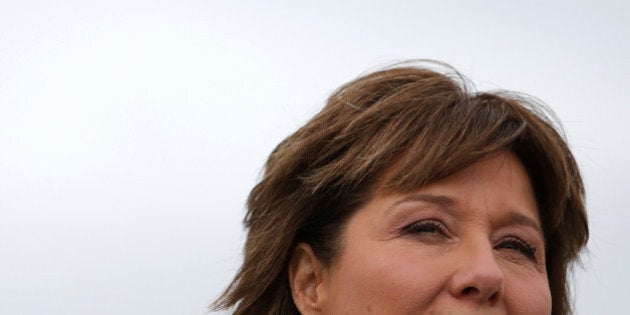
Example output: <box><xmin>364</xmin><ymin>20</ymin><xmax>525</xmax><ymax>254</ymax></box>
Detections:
<box><xmin>321</xmin><ymin>152</ymin><xmax>551</xmax><ymax>314</ymax></box>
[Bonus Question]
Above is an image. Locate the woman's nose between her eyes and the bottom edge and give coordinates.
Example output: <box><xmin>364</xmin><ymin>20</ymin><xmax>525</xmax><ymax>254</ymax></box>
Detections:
<box><xmin>450</xmin><ymin>244</ymin><xmax>503</xmax><ymax>305</ymax></box>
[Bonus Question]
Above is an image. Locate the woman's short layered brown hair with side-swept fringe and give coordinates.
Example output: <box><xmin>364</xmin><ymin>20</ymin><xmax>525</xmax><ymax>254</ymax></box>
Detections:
<box><xmin>214</xmin><ymin>61</ymin><xmax>588</xmax><ymax>314</ymax></box>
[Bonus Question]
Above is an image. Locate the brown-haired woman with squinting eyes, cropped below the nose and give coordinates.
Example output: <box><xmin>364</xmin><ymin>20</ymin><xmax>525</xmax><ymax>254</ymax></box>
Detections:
<box><xmin>215</xmin><ymin>62</ymin><xmax>588</xmax><ymax>314</ymax></box>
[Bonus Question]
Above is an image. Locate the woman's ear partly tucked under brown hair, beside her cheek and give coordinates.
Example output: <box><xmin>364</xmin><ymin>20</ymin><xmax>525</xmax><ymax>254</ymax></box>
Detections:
<box><xmin>289</xmin><ymin>243</ymin><xmax>328</xmax><ymax>314</ymax></box>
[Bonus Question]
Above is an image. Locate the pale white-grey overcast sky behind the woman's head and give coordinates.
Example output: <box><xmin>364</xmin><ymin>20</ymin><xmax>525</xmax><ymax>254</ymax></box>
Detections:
<box><xmin>0</xmin><ymin>0</ymin><xmax>630</xmax><ymax>314</ymax></box>
